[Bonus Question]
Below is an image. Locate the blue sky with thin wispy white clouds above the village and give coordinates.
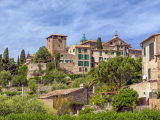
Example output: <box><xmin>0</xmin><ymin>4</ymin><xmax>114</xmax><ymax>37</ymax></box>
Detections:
<box><xmin>0</xmin><ymin>0</ymin><xmax>160</xmax><ymax>61</ymax></box>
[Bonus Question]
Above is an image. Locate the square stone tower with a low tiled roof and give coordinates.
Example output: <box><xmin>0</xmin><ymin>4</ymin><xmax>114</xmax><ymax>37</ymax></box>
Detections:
<box><xmin>46</xmin><ymin>34</ymin><xmax>67</xmax><ymax>55</ymax></box>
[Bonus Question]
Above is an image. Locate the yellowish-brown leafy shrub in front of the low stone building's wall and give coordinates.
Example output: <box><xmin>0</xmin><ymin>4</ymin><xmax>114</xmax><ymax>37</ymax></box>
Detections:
<box><xmin>53</xmin><ymin>96</ymin><xmax>73</xmax><ymax>115</ymax></box>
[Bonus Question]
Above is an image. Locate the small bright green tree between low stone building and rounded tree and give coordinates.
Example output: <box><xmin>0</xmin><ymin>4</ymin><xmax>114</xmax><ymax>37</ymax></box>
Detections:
<box><xmin>89</xmin><ymin>92</ymin><xmax>109</xmax><ymax>107</ymax></box>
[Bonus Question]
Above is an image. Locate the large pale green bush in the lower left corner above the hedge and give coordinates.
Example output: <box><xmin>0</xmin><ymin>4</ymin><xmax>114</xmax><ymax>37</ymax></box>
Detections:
<box><xmin>0</xmin><ymin>95</ymin><xmax>55</xmax><ymax>116</ymax></box>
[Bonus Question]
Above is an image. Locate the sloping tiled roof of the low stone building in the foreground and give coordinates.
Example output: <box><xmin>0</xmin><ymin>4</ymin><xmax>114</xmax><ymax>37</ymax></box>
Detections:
<box><xmin>40</xmin><ymin>88</ymin><xmax>83</xmax><ymax>98</ymax></box>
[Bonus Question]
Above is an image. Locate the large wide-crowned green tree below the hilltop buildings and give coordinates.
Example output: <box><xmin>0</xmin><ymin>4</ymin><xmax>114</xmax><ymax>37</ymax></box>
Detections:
<box><xmin>94</xmin><ymin>56</ymin><xmax>135</xmax><ymax>89</ymax></box>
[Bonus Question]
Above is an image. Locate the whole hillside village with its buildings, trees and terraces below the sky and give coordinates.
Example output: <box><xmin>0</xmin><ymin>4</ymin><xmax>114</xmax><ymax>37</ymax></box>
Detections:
<box><xmin>0</xmin><ymin>32</ymin><xmax>160</xmax><ymax>115</ymax></box>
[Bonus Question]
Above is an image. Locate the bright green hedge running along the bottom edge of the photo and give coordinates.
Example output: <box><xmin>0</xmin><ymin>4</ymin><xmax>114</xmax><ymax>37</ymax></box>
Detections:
<box><xmin>0</xmin><ymin>109</ymin><xmax>160</xmax><ymax>120</ymax></box>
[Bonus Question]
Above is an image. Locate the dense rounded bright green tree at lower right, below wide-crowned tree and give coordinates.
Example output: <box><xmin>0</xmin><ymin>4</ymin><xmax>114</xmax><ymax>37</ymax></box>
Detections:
<box><xmin>111</xmin><ymin>88</ymin><xmax>139</xmax><ymax>110</ymax></box>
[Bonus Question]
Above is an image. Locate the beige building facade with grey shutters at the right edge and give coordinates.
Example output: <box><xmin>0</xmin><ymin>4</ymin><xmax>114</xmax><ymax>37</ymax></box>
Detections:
<box><xmin>141</xmin><ymin>34</ymin><xmax>160</xmax><ymax>89</ymax></box>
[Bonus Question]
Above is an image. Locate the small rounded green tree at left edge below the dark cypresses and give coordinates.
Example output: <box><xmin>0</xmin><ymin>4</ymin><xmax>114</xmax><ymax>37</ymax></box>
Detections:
<box><xmin>0</xmin><ymin>70</ymin><xmax>11</xmax><ymax>87</ymax></box>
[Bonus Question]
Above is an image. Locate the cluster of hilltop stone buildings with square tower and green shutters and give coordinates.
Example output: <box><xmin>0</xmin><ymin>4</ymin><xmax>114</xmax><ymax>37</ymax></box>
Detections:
<box><xmin>47</xmin><ymin>33</ymin><xmax>142</xmax><ymax>74</ymax></box>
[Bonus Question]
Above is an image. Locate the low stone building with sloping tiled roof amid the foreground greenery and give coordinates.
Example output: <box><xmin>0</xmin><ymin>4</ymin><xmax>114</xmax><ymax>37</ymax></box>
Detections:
<box><xmin>39</xmin><ymin>84</ymin><xmax>94</xmax><ymax>112</ymax></box>
